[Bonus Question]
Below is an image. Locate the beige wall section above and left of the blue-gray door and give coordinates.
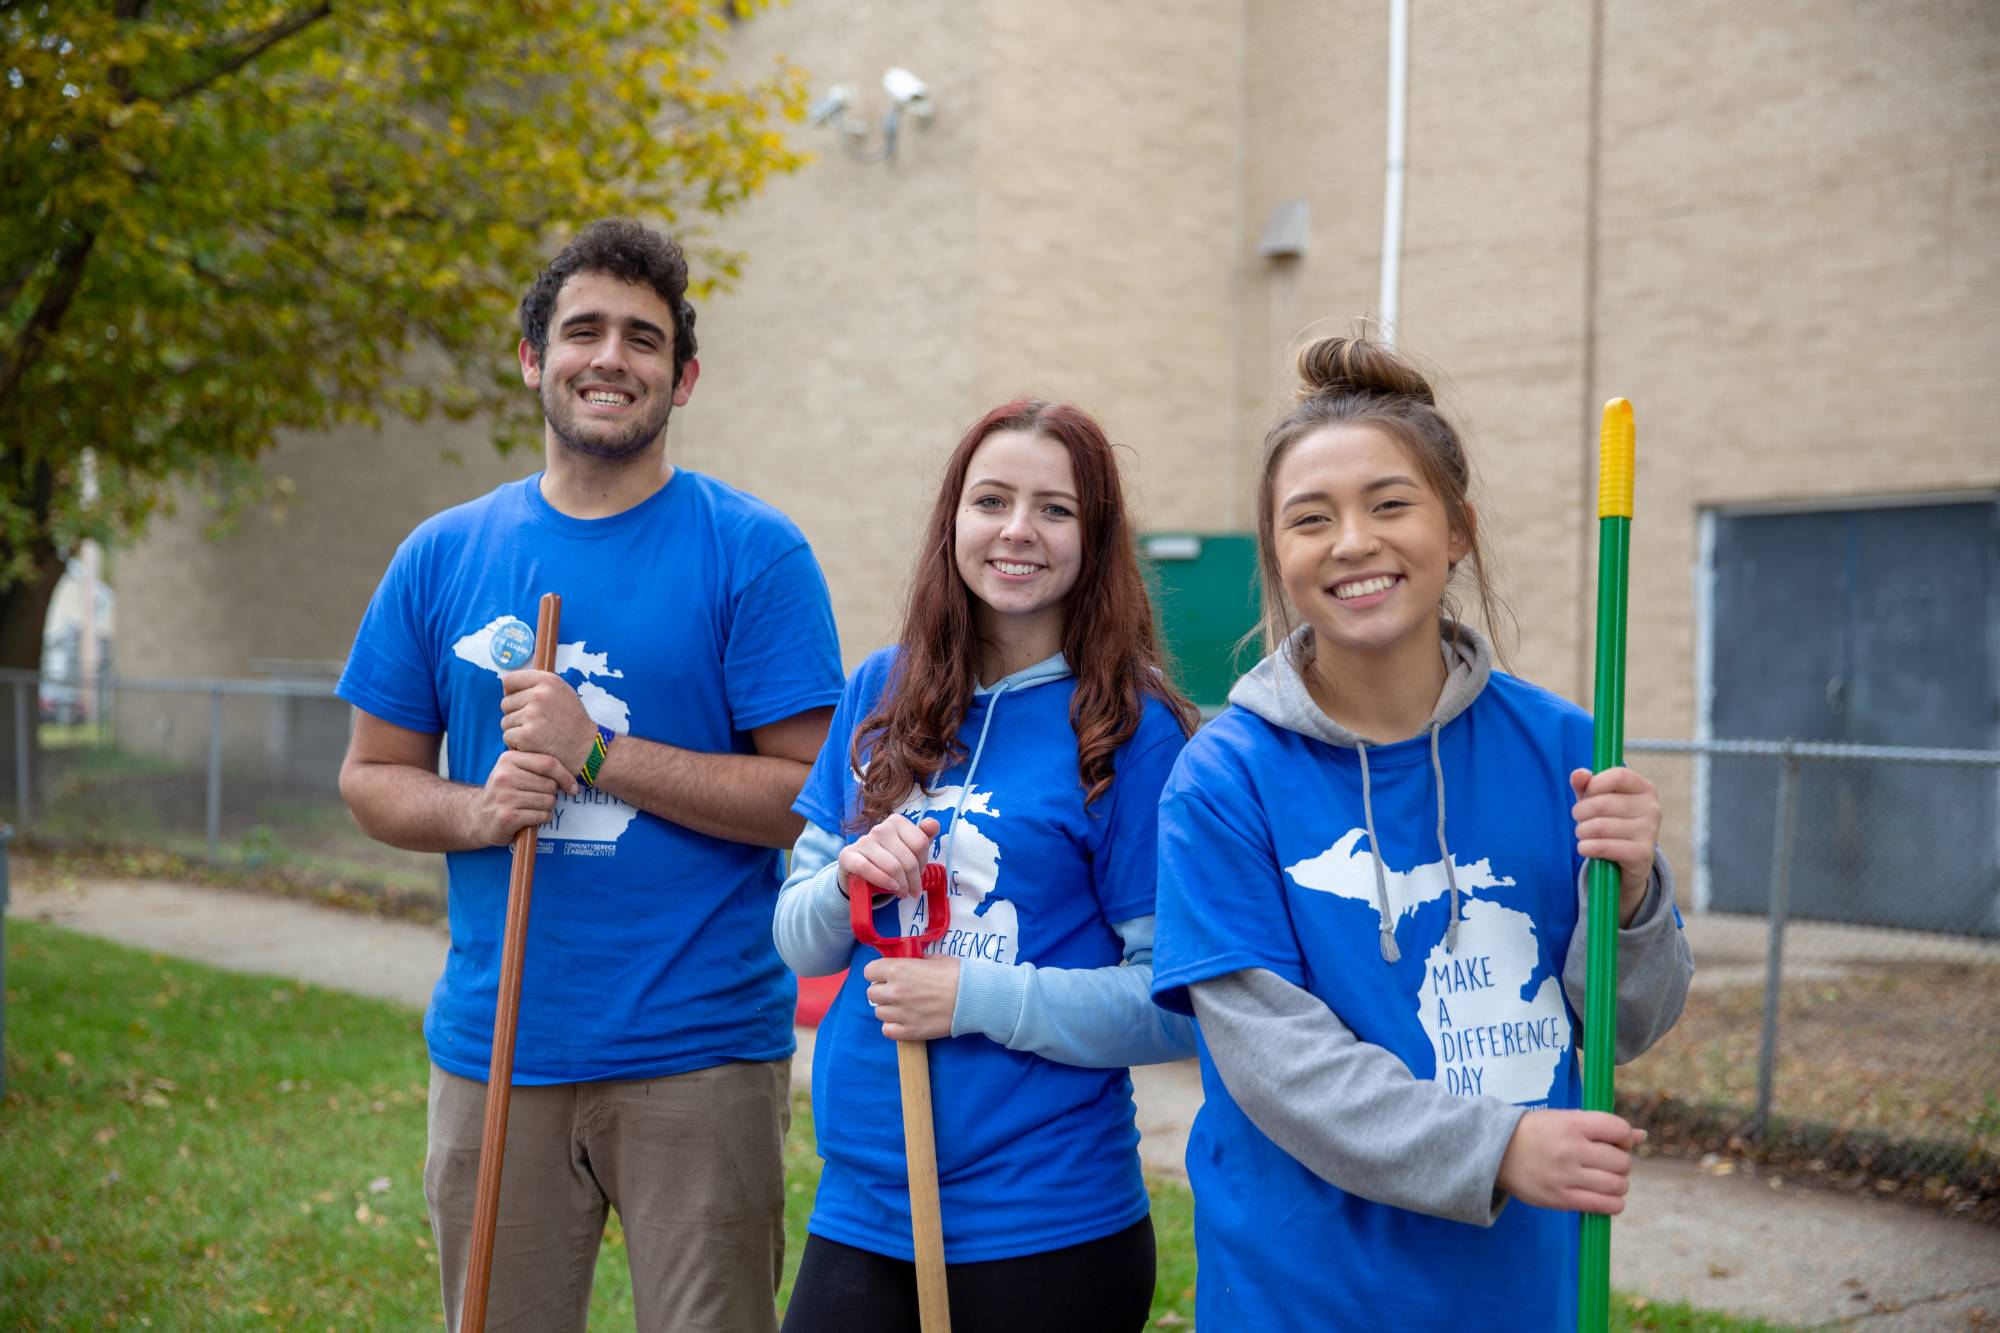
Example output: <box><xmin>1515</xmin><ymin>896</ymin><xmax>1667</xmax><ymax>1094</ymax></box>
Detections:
<box><xmin>1576</xmin><ymin>0</ymin><xmax>2000</xmax><ymax>893</ymax></box>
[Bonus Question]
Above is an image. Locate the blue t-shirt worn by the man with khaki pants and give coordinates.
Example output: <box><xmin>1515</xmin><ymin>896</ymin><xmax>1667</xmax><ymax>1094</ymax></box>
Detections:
<box><xmin>338</xmin><ymin>470</ymin><xmax>840</xmax><ymax>1083</ymax></box>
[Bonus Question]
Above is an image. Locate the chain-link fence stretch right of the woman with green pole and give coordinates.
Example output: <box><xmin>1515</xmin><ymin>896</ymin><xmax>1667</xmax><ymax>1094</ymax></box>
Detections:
<box><xmin>1618</xmin><ymin>741</ymin><xmax>2000</xmax><ymax>1207</ymax></box>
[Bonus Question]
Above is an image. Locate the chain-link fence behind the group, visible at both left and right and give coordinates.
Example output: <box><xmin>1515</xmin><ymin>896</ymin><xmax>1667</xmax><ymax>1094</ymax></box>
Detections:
<box><xmin>15</xmin><ymin>671</ymin><xmax>2000</xmax><ymax>1203</ymax></box>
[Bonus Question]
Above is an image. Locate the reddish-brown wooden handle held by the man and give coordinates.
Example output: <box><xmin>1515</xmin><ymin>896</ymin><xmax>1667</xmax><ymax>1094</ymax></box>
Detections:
<box><xmin>458</xmin><ymin>592</ymin><xmax>562</xmax><ymax>1333</ymax></box>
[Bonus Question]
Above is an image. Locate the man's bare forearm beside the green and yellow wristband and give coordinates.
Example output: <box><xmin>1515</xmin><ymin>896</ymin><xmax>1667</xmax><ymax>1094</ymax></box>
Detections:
<box><xmin>598</xmin><ymin>737</ymin><xmax>810</xmax><ymax>847</ymax></box>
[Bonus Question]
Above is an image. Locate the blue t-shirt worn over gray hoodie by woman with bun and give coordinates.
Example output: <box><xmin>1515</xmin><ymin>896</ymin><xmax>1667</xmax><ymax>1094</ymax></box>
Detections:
<box><xmin>1154</xmin><ymin>673</ymin><xmax>1590</xmax><ymax>1333</ymax></box>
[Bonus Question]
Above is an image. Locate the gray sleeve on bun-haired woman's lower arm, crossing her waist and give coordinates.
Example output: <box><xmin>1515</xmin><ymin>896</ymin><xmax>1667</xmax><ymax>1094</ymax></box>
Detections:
<box><xmin>1188</xmin><ymin>967</ymin><xmax>1526</xmax><ymax>1227</ymax></box>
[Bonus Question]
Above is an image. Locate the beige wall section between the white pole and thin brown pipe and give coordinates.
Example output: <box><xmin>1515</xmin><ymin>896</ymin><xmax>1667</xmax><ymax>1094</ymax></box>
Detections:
<box><xmin>1398</xmin><ymin>0</ymin><xmax>1596</xmax><ymax>699</ymax></box>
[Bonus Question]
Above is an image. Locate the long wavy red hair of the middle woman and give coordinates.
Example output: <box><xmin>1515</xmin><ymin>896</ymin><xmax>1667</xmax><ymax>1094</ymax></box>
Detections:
<box><xmin>850</xmin><ymin>398</ymin><xmax>1196</xmax><ymax>831</ymax></box>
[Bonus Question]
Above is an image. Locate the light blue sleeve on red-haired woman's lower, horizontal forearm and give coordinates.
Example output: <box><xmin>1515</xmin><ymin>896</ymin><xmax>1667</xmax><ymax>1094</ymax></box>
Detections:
<box><xmin>952</xmin><ymin>917</ymin><xmax>1194</xmax><ymax>1069</ymax></box>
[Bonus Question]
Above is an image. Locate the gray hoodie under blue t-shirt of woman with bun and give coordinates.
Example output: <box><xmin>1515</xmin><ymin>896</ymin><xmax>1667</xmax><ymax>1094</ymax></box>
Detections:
<box><xmin>1190</xmin><ymin>622</ymin><xmax>1694</xmax><ymax>1225</ymax></box>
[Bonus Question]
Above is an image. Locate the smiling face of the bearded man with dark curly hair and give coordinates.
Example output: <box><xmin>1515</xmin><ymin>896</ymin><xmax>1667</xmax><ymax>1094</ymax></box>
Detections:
<box><xmin>520</xmin><ymin>272</ymin><xmax>700</xmax><ymax>460</ymax></box>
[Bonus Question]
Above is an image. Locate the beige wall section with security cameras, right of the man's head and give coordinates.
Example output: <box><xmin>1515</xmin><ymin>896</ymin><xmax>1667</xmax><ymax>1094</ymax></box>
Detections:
<box><xmin>696</xmin><ymin>0</ymin><xmax>1242</xmax><ymax>664</ymax></box>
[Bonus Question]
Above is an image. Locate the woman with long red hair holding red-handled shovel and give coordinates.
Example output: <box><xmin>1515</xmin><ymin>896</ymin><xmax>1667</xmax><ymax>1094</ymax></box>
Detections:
<box><xmin>774</xmin><ymin>400</ymin><xmax>1194</xmax><ymax>1333</ymax></box>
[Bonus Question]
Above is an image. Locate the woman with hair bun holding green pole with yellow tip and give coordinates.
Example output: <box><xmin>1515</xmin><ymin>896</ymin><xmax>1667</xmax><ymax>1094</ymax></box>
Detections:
<box><xmin>1154</xmin><ymin>338</ymin><xmax>1694</xmax><ymax>1333</ymax></box>
